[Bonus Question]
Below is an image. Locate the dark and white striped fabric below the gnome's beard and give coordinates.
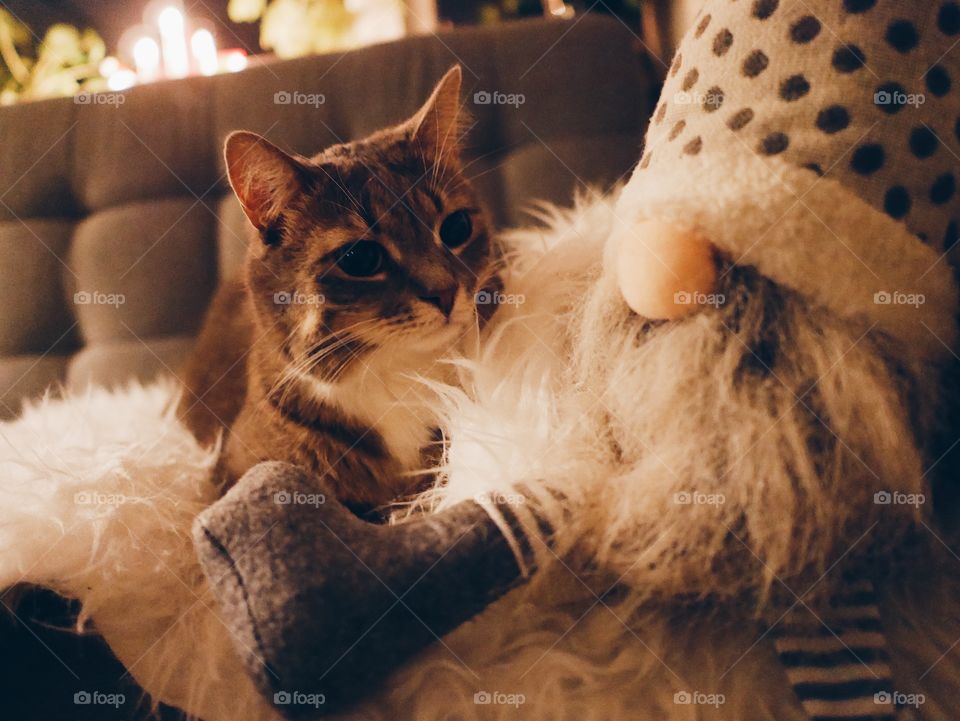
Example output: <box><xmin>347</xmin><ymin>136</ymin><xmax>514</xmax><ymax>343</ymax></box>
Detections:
<box><xmin>770</xmin><ymin>581</ymin><xmax>896</xmax><ymax>721</ymax></box>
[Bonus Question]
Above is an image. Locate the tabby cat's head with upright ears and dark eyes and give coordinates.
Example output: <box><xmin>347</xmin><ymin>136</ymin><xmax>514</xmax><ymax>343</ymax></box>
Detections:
<box><xmin>225</xmin><ymin>66</ymin><xmax>495</xmax><ymax>378</ymax></box>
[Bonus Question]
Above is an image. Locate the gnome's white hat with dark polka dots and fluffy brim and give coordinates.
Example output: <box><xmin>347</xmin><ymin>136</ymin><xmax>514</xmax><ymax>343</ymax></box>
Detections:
<box><xmin>618</xmin><ymin>0</ymin><xmax>960</xmax><ymax>355</ymax></box>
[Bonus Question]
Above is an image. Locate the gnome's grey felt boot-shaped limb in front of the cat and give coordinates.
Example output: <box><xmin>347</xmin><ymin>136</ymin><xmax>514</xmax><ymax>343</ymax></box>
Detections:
<box><xmin>194</xmin><ymin>462</ymin><xmax>522</xmax><ymax>719</ymax></box>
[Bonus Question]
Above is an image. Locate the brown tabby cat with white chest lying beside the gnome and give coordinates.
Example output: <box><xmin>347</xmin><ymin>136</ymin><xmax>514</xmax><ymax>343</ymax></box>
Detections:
<box><xmin>179</xmin><ymin>66</ymin><xmax>497</xmax><ymax>506</ymax></box>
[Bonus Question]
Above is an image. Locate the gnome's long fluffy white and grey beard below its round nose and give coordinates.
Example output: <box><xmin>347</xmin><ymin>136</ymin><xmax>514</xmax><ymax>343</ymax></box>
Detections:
<box><xmin>441</xmin><ymin>190</ymin><xmax>937</xmax><ymax>605</ymax></box>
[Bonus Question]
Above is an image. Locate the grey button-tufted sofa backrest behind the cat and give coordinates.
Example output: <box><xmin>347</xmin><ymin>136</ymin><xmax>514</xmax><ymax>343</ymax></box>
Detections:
<box><xmin>0</xmin><ymin>16</ymin><xmax>652</xmax><ymax>416</ymax></box>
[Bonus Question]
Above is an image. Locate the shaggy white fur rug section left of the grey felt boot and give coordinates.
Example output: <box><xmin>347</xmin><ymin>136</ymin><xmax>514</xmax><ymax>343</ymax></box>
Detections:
<box><xmin>0</xmin><ymin>381</ymin><xmax>274</xmax><ymax>721</ymax></box>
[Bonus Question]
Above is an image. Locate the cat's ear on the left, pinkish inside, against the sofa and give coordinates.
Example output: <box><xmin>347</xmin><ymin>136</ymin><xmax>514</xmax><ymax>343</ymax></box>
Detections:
<box><xmin>223</xmin><ymin>130</ymin><xmax>302</xmax><ymax>231</ymax></box>
